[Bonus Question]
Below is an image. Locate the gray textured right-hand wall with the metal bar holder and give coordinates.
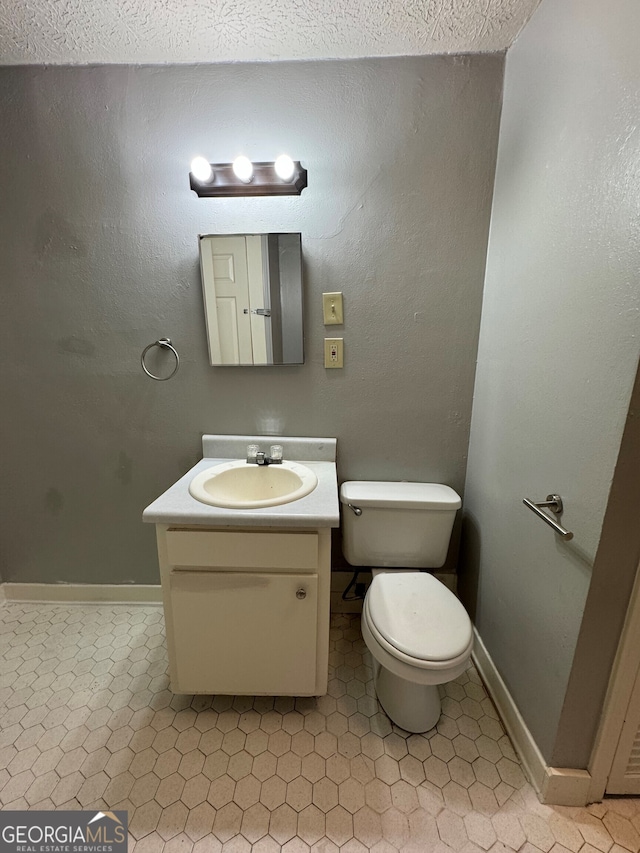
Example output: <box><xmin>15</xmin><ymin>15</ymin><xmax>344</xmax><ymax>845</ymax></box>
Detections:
<box><xmin>463</xmin><ymin>0</ymin><xmax>640</xmax><ymax>766</ymax></box>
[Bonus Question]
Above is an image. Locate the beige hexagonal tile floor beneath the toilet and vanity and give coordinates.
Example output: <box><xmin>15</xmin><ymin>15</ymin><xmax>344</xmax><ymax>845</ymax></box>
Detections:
<box><xmin>0</xmin><ymin>603</ymin><xmax>640</xmax><ymax>853</ymax></box>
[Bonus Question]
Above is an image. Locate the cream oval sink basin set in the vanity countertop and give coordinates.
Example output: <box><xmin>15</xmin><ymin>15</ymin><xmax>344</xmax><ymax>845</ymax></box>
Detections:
<box><xmin>189</xmin><ymin>460</ymin><xmax>318</xmax><ymax>509</ymax></box>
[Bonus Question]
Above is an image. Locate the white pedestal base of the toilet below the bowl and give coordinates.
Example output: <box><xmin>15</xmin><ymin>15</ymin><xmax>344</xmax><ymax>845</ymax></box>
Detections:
<box><xmin>374</xmin><ymin>666</ymin><xmax>441</xmax><ymax>734</ymax></box>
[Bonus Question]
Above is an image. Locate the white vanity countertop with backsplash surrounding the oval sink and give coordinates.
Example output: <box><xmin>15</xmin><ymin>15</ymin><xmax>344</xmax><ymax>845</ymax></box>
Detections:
<box><xmin>142</xmin><ymin>436</ymin><xmax>340</xmax><ymax>527</ymax></box>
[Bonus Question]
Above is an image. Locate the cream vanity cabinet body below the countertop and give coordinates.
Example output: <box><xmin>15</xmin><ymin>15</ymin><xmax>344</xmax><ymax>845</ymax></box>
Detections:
<box><xmin>156</xmin><ymin>524</ymin><xmax>331</xmax><ymax>696</ymax></box>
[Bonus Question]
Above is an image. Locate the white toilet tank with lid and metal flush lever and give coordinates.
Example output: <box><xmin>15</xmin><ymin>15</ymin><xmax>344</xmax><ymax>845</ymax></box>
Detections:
<box><xmin>340</xmin><ymin>480</ymin><xmax>462</xmax><ymax>569</ymax></box>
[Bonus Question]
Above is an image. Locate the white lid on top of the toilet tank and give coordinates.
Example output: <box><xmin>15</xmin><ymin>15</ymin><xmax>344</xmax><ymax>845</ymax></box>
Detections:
<box><xmin>340</xmin><ymin>480</ymin><xmax>462</xmax><ymax>511</ymax></box>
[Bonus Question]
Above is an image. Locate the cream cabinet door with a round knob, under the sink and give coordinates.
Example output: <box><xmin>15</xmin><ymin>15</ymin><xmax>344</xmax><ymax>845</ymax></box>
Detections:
<box><xmin>169</xmin><ymin>571</ymin><xmax>318</xmax><ymax>696</ymax></box>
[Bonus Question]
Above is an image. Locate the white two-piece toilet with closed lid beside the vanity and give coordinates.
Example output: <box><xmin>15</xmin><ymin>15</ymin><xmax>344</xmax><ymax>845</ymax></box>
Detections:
<box><xmin>340</xmin><ymin>481</ymin><xmax>473</xmax><ymax>732</ymax></box>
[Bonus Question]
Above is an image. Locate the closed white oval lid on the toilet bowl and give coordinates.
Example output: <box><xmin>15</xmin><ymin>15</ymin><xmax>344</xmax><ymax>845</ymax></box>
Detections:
<box><xmin>367</xmin><ymin>572</ymin><xmax>471</xmax><ymax>661</ymax></box>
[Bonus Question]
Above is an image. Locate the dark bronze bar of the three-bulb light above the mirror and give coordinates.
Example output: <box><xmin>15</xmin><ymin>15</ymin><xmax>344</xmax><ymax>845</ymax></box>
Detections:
<box><xmin>189</xmin><ymin>160</ymin><xmax>307</xmax><ymax>198</ymax></box>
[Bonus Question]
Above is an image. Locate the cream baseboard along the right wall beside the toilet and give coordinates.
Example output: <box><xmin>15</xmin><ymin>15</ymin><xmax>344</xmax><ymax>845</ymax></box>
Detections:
<box><xmin>473</xmin><ymin>628</ymin><xmax>591</xmax><ymax>806</ymax></box>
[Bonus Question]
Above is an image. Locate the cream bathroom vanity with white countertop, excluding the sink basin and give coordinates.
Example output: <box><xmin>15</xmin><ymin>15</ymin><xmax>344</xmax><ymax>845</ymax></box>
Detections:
<box><xmin>143</xmin><ymin>436</ymin><xmax>339</xmax><ymax>696</ymax></box>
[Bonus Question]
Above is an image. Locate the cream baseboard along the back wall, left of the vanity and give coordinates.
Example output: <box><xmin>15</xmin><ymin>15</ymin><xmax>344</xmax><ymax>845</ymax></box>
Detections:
<box><xmin>0</xmin><ymin>583</ymin><xmax>162</xmax><ymax>604</ymax></box>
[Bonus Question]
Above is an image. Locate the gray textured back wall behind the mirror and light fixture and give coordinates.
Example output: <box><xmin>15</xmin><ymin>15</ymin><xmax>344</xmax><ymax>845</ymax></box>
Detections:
<box><xmin>0</xmin><ymin>55</ymin><xmax>503</xmax><ymax>583</ymax></box>
